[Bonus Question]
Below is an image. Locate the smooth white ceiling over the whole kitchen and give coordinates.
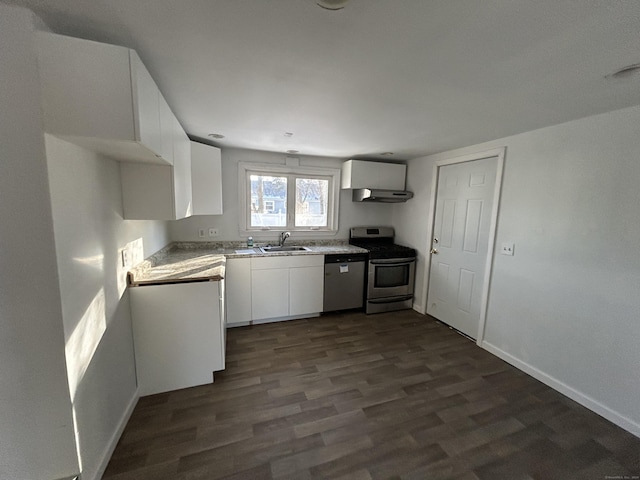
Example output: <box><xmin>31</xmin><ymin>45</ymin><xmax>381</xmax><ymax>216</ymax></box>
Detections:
<box><xmin>5</xmin><ymin>0</ymin><xmax>640</xmax><ymax>159</ymax></box>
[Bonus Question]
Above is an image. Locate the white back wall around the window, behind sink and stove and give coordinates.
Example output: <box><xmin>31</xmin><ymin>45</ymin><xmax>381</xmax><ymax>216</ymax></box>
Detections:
<box><xmin>171</xmin><ymin>149</ymin><xmax>393</xmax><ymax>242</ymax></box>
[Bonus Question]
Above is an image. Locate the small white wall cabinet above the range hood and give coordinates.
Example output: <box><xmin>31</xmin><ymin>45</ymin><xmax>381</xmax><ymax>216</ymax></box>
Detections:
<box><xmin>341</xmin><ymin>160</ymin><xmax>407</xmax><ymax>190</ymax></box>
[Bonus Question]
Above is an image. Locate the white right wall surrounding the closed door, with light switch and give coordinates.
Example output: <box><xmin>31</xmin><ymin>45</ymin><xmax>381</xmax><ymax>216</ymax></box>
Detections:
<box><xmin>394</xmin><ymin>107</ymin><xmax>640</xmax><ymax>436</ymax></box>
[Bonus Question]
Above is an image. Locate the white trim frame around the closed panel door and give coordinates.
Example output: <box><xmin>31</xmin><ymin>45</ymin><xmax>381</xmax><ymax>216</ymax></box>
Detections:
<box><xmin>424</xmin><ymin>147</ymin><xmax>507</xmax><ymax>346</ymax></box>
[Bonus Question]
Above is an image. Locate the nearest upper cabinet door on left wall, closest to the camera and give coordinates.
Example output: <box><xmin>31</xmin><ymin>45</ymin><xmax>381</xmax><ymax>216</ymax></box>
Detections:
<box><xmin>129</xmin><ymin>50</ymin><xmax>162</xmax><ymax>157</ymax></box>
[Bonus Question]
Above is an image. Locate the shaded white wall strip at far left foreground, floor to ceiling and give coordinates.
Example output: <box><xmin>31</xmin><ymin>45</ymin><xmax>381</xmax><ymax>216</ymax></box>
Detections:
<box><xmin>0</xmin><ymin>3</ymin><xmax>79</xmax><ymax>480</ymax></box>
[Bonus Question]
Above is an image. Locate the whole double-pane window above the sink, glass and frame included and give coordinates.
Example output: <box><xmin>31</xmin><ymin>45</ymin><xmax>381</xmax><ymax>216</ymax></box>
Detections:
<box><xmin>239</xmin><ymin>163</ymin><xmax>340</xmax><ymax>233</ymax></box>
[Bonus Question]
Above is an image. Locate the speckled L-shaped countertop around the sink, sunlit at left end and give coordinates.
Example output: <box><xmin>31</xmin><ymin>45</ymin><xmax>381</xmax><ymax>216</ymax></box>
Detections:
<box><xmin>127</xmin><ymin>240</ymin><xmax>367</xmax><ymax>286</ymax></box>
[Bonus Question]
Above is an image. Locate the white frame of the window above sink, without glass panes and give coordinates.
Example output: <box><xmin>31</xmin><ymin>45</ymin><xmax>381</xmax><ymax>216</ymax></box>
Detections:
<box><xmin>238</xmin><ymin>162</ymin><xmax>340</xmax><ymax>236</ymax></box>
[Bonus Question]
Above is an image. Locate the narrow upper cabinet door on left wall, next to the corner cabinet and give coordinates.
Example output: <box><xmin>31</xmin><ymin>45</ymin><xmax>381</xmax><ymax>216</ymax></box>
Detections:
<box><xmin>173</xmin><ymin>117</ymin><xmax>193</xmax><ymax>220</ymax></box>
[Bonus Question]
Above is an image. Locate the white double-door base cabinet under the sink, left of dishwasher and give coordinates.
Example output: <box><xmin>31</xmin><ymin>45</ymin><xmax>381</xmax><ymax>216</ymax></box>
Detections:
<box><xmin>251</xmin><ymin>255</ymin><xmax>324</xmax><ymax>320</ymax></box>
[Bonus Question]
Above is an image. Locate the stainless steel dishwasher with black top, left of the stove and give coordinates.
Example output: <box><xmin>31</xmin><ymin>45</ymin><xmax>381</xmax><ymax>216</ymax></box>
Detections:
<box><xmin>322</xmin><ymin>253</ymin><xmax>367</xmax><ymax>312</ymax></box>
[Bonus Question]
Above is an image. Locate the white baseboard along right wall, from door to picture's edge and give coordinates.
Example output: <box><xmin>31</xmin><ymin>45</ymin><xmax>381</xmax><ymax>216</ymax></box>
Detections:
<box><xmin>481</xmin><ymin>341</ymin><xmax>640</xmax><ymax>437</ymax></box>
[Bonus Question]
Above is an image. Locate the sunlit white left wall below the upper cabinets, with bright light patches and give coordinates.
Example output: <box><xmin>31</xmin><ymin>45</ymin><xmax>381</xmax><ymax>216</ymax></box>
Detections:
<box><xmin>46</xmin><ymin>135</ymin><xmax>169</xmax><ymax>479</ymax></box>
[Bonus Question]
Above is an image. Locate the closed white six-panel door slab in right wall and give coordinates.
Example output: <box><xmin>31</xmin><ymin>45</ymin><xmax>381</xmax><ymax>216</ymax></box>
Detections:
<box><xmin>427</xmin><ymin>157</ymin><xmax>498</xmax><ymax>339</ymax></box>
